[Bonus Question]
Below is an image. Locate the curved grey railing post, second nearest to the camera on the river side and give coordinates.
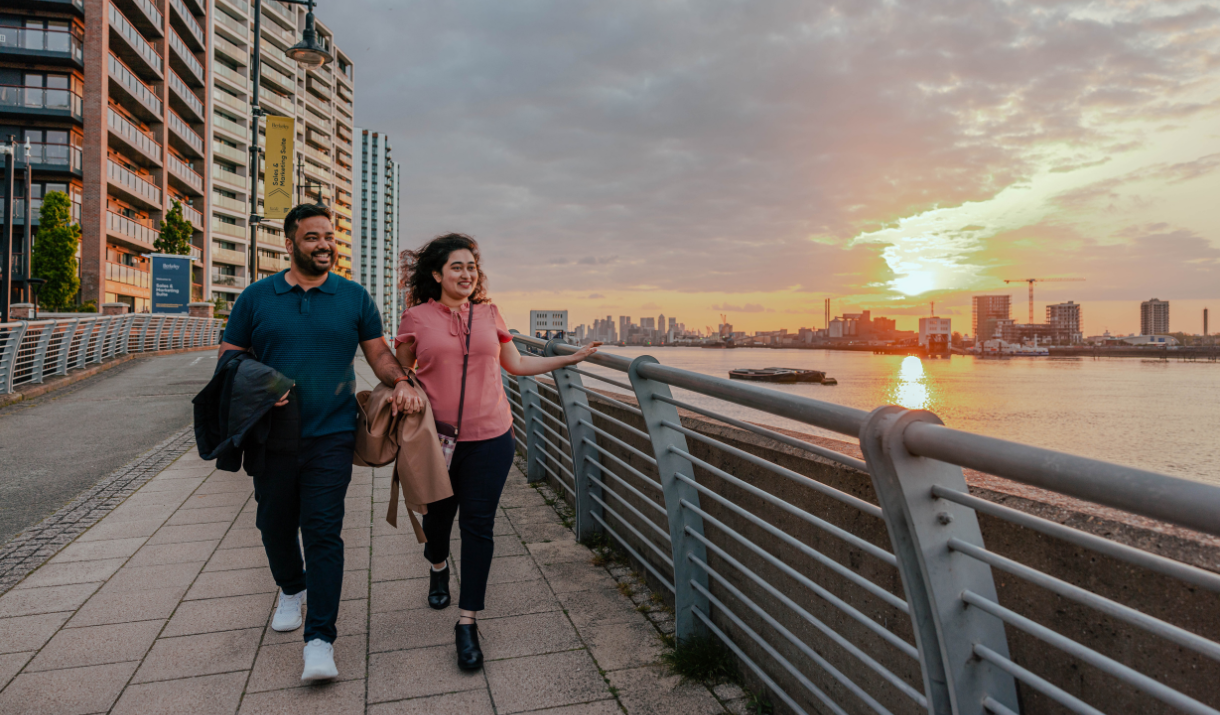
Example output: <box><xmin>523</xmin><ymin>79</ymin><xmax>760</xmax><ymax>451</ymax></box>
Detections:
<box><xmin>628</xmin><ymin>355</ymin><xmax>711</xmax><ymax>641</ymax></box>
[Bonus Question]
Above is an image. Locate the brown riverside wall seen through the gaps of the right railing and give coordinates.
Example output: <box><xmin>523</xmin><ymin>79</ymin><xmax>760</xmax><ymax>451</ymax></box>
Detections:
<box><xmin>534</xmin><ymin>378</ymin><xmax>1220</xmax><ymax>715</ymax></box>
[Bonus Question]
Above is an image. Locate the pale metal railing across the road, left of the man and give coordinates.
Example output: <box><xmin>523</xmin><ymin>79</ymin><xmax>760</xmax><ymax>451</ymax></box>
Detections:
<box><xmin>0</xmin><ymin>314</ymin><xmax>223</xmax><ymax>394</ymax></box>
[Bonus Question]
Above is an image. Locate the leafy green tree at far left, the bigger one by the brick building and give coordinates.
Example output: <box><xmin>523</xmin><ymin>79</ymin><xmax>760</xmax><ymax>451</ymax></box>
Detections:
<box><xmin>33</xmin><ymin>192</ymin><xmax>81</xmax><ymax>311</ymax></box>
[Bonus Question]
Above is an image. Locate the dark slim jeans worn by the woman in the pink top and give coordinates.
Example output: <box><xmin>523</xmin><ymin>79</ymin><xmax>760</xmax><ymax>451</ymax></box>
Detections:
<box><xmin>423</xmin><ymin>429</ymin><xmax>516</xmax><ymax>611</ymax></box>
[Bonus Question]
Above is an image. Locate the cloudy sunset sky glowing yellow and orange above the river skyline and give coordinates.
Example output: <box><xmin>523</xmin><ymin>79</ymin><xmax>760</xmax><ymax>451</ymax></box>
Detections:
<box><xmin>317</xmin><ymin>0</ymin><xmax>1220</xmax><ymax>334</ymax></box>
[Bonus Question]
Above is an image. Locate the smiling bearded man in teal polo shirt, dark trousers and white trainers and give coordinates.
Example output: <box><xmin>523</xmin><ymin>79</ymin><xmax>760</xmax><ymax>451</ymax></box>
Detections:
<box><xmin>221</xmin><ymin>204</ymin><xmax>423</xmax><ymax>681</ymax></box>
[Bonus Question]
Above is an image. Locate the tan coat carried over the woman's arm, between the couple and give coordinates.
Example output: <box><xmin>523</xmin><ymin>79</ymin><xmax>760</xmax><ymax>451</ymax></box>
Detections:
<box><xmin>351</xmin><ymin>372</ymin><xmax>454</xmax><ymax>536</ymax></box>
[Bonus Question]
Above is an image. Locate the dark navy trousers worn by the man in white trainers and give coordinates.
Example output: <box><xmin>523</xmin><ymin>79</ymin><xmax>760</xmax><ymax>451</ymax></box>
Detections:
<box><xmin>254</xmin><ymin>432</ymin><xmax>356</xmax><ymax>643</ymax></box>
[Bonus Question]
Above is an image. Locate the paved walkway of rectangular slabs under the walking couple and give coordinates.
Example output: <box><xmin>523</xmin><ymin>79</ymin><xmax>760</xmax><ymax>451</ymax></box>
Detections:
<box><xmin>0</xmin><ymin>363</ymin><xmax>744</xmax><ymax>715</ymax></box>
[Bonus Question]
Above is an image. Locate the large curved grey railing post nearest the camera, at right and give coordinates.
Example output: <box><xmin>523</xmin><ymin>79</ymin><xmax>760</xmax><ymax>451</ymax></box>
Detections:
<box><xmin>860</xmin><ymin>406</ymin><xmax>1020</xmax><ymax>715</ymax></box>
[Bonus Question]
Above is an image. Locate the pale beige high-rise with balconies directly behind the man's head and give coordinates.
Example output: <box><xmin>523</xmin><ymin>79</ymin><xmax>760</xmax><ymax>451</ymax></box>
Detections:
<box><xmin>206</xmin><ymin>0</ymin><xmax>354</xmax><ymax>305</ymax></box>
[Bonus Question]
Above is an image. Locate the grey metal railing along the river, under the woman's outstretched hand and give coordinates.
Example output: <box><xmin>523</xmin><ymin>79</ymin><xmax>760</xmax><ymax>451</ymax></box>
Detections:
<box><xmin>504</xmin><ymin>336</ymin><xmax>1220</xmax><ymax>715</ymax></box>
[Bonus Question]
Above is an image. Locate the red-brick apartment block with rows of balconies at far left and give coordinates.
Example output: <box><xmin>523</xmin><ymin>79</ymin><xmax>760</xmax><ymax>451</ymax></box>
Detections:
<box><xmin>0</xmin><ymin>0</ymin><xmax>211</xmax><ymax>311</ymax></box>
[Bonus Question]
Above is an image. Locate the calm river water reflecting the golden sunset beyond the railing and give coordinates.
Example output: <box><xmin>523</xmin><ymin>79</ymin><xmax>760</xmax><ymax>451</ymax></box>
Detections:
<box><xmin>570</xmin><ymin>347</ymin><xmax>1220</xmax><ymax>484</ymax></box>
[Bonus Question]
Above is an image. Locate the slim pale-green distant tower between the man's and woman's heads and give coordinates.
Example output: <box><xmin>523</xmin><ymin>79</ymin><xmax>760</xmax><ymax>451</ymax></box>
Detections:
<box><xmin>353</xmin><ymin>127</ymin><xmax>404</xmax><ymax>336</ymax></box>
